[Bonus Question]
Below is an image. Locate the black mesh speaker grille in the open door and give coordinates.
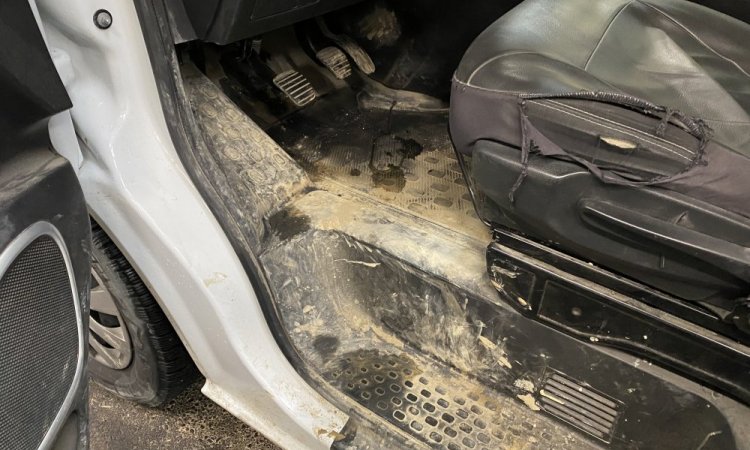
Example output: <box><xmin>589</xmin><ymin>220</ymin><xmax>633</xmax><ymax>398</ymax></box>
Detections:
<box><xmin>0</xmin><ymin>236</ymin><xmax>78</xmax><ymax>449</ymax></box>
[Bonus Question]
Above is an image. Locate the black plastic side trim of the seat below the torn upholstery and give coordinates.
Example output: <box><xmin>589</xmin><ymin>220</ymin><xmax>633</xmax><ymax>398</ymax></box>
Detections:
<box><xmin>469</xmin><ymin>141</ymin><xmax>750</xmax><ymax>306</ymax></box>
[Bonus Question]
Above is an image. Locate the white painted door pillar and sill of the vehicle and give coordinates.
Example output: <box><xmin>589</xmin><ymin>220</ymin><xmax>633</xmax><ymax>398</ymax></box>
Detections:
<box><xmin>36</xmin><ymin>0</ymin><xmax>348</xmax><ymax>449</ymax></box>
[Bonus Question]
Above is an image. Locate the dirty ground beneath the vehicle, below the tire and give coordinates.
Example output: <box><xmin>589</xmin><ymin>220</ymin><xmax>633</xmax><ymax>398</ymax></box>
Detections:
<box><xmin>89</xmin><ymin>382</ymin><xmax>278</xmax><ymax>450</ymax></box>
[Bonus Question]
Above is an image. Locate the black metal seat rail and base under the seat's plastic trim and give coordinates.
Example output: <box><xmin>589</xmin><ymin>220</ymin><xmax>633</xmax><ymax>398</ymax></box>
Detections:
<box><xmin>487</xmin><ymin>230</ymin><xmax>750</xmax><ymax>402</ymax></box>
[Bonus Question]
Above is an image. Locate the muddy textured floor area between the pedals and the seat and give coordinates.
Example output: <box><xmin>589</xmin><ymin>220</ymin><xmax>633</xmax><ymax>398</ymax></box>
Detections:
<box><xmin>267</xmin><ymin>90</ymin><xmax>486</xmax><ymax>238</ymax></box>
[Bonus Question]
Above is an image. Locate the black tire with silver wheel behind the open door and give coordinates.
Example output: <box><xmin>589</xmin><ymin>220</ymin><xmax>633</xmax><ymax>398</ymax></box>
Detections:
<box><xmin>89</xmin><ymin>221</ymin><xmax>199</xmax><ymax>406</ymax></box>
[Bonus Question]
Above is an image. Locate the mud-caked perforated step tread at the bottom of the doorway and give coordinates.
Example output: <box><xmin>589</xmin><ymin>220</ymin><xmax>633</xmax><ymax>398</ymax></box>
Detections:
<box><xmin>326</xmin><ymin>351</ymin><xmax>576</xmax><ymax>450</ymax></box>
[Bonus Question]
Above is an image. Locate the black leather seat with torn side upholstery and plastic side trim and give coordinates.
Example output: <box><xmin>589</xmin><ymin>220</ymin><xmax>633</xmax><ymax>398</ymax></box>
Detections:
<box><xmin>451</xmin><ymin>0</ymin><xmax>750</xmax><ymax>309</ymax></box>
